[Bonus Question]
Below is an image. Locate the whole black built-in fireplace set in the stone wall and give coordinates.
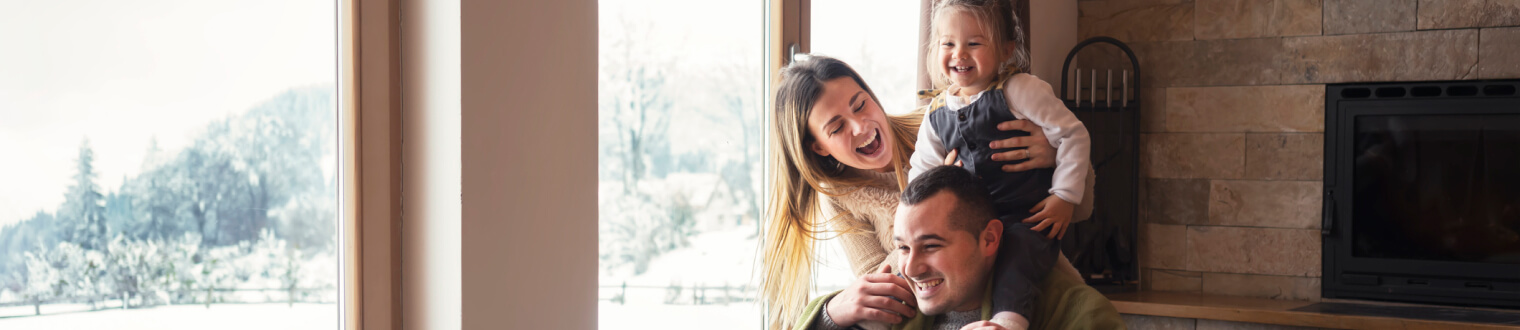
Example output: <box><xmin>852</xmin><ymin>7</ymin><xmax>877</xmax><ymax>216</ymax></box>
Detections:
<box><xmin>1322</xmin><ymin>81</ymin><xmax>1520</xmax><ymax>307</ymax></box>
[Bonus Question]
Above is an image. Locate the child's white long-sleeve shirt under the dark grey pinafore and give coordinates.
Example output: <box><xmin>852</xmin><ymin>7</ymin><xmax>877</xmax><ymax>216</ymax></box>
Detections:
<box><xmin>907</xmin><ymin>73</ymin><xmax>1091</xmax><ymax>205</ymax></box>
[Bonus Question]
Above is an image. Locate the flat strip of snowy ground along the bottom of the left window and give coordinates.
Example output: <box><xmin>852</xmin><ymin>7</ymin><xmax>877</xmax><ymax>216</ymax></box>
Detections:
<box><xmin>0</xmin><ymin>304</ymin><xmax>337</xmax><ymax>330</ymax></box>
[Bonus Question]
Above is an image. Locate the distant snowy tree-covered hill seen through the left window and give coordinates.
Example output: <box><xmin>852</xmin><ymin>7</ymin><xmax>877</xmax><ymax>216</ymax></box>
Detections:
<box><xmin>0</xmin><ymin>85</ymin><xmax>337</xmax><ymax>289</ymax></box>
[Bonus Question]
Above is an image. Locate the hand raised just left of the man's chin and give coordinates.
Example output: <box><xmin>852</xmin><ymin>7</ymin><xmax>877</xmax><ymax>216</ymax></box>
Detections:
<box><xmin>824</xmin><ymin>265</ymin><xmax>918</xmax><ymax>327</ymax></box>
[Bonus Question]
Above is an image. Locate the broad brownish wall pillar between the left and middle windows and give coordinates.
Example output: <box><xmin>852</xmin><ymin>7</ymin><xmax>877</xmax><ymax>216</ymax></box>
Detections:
<box><xmin>452</xmin><ymin>0</ymin><xmax>597</xmax><ymax>328</ymax></box>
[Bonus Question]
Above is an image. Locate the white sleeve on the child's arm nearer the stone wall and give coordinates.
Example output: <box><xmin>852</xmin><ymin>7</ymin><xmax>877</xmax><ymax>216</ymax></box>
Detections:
<box><xmin>1003</xmin><ymin>73</ymin><xmax>1091</xmax><ymax>205</ymax></box>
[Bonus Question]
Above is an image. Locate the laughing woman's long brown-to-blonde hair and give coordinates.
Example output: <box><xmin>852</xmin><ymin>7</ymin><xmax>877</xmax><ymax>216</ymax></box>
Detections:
<box><xmin>760</xmin><ymin>56</ymin><xmax>923</xmax><ymax>328</ymax></box>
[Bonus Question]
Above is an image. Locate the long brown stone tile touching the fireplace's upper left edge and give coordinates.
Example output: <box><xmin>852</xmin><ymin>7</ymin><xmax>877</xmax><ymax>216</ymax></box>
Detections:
<box><xmin>1166</xmin><ymin>85</ymin><xmax>1325</xmax><ymax>132</ymax></box>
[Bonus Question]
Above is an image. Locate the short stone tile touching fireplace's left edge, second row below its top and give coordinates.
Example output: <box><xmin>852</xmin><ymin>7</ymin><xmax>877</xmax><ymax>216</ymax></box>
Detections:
<box><xmin>1245</xmin><ymin>132</ymin><xmax>1325</xmax><ymax>181</ymax></box>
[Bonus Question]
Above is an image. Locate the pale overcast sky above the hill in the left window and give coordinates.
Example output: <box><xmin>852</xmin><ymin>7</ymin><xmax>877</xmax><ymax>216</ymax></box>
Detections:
<box><xmin>0</xmin><ymin>0</ymin><xmax>336</xmax><ymax>225</ymax></box>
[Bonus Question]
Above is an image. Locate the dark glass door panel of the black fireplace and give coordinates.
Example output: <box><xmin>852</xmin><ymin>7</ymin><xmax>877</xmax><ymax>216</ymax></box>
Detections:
<box><xmin>1351</xmin><ymin>114</ymin><xmax>1520</xmax><ymax>263</ymax></box>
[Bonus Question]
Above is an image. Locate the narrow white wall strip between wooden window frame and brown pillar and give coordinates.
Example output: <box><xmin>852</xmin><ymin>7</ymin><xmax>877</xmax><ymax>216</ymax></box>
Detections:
<box><xmin>400</xmin><ymin>0</ymin><xmax>464</xmax><ymax>330</ymax></box>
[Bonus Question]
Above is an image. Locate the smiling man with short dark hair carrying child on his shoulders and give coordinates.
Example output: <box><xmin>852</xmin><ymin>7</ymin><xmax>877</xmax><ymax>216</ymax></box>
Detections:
<box><xmin>796</xmin><ymin>166</ymin><xmax>1125</xmax><ymax>330</ymax></box>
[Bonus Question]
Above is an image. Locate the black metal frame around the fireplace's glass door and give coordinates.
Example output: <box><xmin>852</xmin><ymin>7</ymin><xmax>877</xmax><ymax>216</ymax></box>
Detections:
<box><xmin>1321</xmin><ymin>81</ymin><xmax>1520</xmax><ymax>309</ymax></box>
